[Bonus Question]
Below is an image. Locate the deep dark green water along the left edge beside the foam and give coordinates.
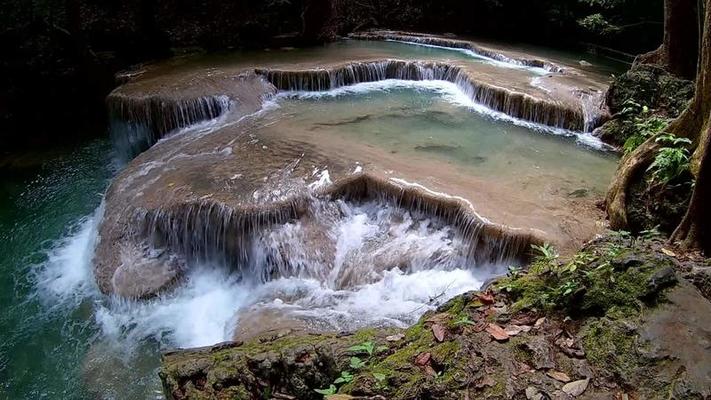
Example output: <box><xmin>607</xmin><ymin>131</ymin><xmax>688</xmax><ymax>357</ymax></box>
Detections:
<box><xmin>0</xmin><ymin>140</ymin><xmax>112</xmax><ymax>399</ymax></box>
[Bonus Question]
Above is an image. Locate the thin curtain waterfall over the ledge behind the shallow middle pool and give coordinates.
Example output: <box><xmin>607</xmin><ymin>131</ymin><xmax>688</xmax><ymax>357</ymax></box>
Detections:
<box><xmin>256</xmin><ymin>60</ymin><xmax>584</xmax><ymax>131</ymax></box>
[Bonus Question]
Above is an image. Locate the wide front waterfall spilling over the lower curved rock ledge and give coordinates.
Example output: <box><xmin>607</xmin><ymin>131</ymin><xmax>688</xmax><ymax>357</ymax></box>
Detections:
<box><xmin>114</xmin><ymin>175</ymin><xmax>540</xmax><ymax>298</ymax></box>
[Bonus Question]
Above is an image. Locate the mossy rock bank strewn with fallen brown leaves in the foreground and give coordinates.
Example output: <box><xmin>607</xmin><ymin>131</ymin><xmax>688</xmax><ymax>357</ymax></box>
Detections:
<box><xmin>161</xmin><ymin>237</ymin><xmax>711</xmax><ymax>399</ymax></box>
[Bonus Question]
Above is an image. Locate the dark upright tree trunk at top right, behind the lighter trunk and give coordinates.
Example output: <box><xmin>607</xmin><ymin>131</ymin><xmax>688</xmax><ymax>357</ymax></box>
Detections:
<box><xmin>635</xmin><ymin>0</ymin><xmax>699</xmax><ymax>80</ymax></box>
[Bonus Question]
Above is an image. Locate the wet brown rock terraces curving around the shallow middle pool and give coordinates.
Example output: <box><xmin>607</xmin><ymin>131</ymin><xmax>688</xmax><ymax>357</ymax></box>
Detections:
<box><xmin>95</xmin><ymin>33</ymin><xmax>616</xmax><ymax>298</ymax></box>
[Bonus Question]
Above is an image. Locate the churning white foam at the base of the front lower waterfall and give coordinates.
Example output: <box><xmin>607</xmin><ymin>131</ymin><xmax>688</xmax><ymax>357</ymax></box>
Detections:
<box><xmin>32</xmin><ymin>194</ymin><xmax>501</xmax><ymax>357</ymax></box>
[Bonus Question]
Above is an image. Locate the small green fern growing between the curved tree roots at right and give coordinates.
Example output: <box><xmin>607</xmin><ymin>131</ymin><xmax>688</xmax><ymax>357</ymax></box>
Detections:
<box><xmin>647</xmin><ymin>135</ymin><xmax>691</xmax><ymax>185</ymax></box>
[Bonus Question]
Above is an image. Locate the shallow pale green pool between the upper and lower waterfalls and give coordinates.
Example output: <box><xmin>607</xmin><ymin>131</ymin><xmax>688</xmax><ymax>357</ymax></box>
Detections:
<box><xmin>267</xmin><ymin>81</ymin><xmax>617</xmax><ymax>196</ymax></box>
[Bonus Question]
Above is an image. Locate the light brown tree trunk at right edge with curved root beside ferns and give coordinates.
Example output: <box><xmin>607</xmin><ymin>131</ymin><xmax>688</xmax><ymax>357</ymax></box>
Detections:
<box><xmin>606</xmin><ymin>0</ymin><xmax>711</xmax><ymax>229</ymax></box>
